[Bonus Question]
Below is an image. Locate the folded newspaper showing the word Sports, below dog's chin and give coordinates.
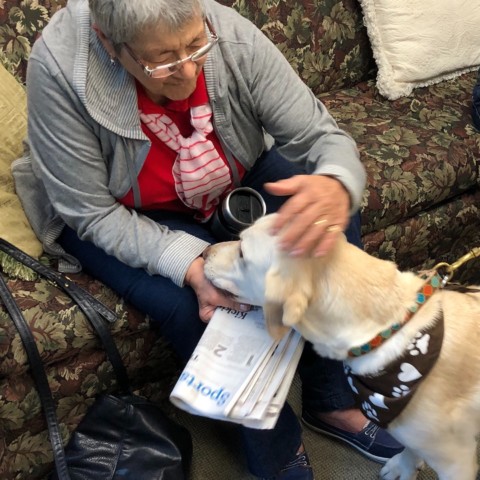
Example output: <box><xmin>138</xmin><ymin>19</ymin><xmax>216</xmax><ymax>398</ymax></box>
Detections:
<box><xmin>170</xmin><ymin>307</ymin><xmax>304</xmax><ymax>429</ymax></box>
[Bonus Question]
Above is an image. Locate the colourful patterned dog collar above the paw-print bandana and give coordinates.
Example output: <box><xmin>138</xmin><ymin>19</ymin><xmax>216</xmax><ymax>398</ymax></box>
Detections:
<box><xmin>348</xmin><ymin>271</ymin><xmax>444</xmax><ymax>358</ymax></box>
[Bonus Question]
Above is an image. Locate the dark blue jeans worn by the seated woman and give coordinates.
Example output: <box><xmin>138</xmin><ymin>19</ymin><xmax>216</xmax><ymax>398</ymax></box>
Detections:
<box><xmin>59</xmin><ymin>149</ymin><xmax>361</xmax><ymax>477</ymax></box>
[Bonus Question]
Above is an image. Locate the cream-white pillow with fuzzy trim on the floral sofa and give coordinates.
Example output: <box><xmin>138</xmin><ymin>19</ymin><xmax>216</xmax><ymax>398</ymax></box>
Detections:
<box><xmin>359</xmin><ymin>0</ymin><xmax>480</xmax><ymax>100</ymax></box>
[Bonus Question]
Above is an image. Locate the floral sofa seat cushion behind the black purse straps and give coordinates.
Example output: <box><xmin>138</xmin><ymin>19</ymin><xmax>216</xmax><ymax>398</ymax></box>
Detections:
<box><xmin>0</xmin><ymin>263</ymin><xmax>163</xmax><ymax>378</ymax></box>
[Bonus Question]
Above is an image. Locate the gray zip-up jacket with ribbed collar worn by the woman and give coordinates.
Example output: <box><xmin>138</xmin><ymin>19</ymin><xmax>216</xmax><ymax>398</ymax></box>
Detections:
<box><xmin>13</xmin><ymin>0</ymin><xmax>365</xmax><ymax>285</ymax></box>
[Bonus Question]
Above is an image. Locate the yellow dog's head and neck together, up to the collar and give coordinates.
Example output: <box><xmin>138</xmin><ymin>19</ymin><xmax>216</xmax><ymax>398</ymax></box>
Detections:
<box><xmin>204</xmin><ymin>214</ymin><xmax>404</xmax><ymax>358</ymax></box>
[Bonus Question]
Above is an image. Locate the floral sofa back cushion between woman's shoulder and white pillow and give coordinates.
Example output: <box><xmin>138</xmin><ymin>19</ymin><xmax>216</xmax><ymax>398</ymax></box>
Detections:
<box><xmin>220</xmin><ymin>0</ymin><xmax>375</xmax><ymax>94</ymax></box>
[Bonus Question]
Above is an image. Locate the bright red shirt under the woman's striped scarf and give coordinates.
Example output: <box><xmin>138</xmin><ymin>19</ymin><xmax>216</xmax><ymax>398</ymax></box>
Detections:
<box><xmin>119</xmin><ymin>72</ymin><xmax>245</xmax><ymax>212</ymax></box>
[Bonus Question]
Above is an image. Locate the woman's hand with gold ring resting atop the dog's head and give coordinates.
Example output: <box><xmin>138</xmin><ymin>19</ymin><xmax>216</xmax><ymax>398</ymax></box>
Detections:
<box><xmin>265</xmin><ymin>175</ymin><xmax>350</xmax><ymax>257</ymax></box>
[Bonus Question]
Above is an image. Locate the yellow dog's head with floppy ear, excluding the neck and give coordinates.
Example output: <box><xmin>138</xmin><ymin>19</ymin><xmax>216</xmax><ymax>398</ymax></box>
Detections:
<box><xmin>204</xmin><ymin>214</ymin><xmax>322</xmax><ymax>338</ymax></box>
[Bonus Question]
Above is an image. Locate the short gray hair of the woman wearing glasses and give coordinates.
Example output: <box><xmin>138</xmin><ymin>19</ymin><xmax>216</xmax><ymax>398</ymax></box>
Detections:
<box><xmin>88</xmin><ymin>0</ymin><xmax>204</xmax><ymax>47</ymax></box>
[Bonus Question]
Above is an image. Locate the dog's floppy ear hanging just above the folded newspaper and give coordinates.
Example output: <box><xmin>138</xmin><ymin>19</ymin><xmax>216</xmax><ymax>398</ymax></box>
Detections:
<box><xmin>263</xmin><ymin>268</ymin><xmax>312</xmax><ymax>339</ymax></box>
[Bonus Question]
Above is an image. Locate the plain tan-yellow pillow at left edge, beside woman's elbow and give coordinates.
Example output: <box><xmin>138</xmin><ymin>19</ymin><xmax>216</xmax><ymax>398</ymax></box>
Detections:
<box><xmin>0</xmin><ymin>64</ymin><xmax>42</xmax><ymax>278</ymax></box>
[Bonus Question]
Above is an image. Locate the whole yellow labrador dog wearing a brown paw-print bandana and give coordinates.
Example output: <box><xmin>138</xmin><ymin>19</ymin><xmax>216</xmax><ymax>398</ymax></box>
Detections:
<box><xmin>204</xmin><ymin>215</ymin><xmax>480</xmax><ymax>480</ymax></box>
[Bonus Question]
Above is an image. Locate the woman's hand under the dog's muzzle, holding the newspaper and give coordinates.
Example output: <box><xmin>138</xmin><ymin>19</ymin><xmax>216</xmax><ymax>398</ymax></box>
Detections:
<box><xmin>185</xmin><ymin>257</ymin><xmax>250</xmax><ymax>322</ymax></box>
